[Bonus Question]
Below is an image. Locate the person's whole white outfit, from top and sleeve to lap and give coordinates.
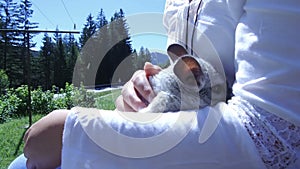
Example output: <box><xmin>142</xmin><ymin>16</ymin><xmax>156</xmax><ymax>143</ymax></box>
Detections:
<box><xmin>62</xmin><ymin>0</ymin><xmax>300</xmax><ymax>169</ymax></box>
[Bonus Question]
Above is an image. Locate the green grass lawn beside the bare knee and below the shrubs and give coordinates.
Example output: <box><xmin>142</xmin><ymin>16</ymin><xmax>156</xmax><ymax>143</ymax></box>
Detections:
<box><xmin>0</xmin><ymin>89</ymin><xmax>121</xmax><ymax>169</ymax></box>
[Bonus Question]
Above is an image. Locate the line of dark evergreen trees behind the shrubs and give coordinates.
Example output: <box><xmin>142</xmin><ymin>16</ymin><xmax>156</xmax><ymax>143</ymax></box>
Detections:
<box><xmin>0</xmin><ymin>0</ymin><xmax>151</xmax><ymax>90</ymax></box>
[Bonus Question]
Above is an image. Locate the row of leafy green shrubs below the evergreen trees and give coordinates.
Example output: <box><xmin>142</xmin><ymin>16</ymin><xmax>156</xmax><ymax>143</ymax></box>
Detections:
<box><xmin>0</xmin><ymin>83</ymin><xmax>120</xmax><ymax>123</ymax></box>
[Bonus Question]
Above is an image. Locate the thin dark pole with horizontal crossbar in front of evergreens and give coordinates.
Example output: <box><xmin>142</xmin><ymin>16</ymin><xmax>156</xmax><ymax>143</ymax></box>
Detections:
<box><xmin>0</xmin><ymin>29</ymin><xmax>80</xmax><ymax>127</ymax></box>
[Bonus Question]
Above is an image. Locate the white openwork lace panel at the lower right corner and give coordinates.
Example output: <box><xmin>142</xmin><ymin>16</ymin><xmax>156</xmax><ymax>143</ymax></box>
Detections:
<box><xmin>229</xmin><ymin>97</ymin><xmax>300</xmax><ymax>169</ymax></box>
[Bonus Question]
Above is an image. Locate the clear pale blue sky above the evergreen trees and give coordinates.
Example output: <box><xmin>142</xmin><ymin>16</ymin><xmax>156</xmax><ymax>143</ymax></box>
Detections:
<box><xmin>31</xmin><ymin>0</ymin><xmax>166</xmax><ymax>50</ymax></box>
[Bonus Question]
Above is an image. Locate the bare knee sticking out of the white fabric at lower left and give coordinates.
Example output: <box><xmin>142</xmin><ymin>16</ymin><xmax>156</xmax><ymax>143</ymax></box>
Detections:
<box><xmin>24</xmin><ymin>110</ymin><xmax>68</xmax><ymax>169</ymax></box>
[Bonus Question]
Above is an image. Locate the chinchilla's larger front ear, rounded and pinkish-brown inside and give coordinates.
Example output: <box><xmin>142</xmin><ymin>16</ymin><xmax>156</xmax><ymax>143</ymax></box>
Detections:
<box><xmin>173</xmin><ymin>55</ymin><xmax>204</xmax><ymax>88</ymax></box>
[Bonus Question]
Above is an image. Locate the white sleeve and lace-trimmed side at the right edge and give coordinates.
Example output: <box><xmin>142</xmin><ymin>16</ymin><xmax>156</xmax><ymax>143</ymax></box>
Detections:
<box><xmin>231</xmin><ymin>0</ymin><xmax>300</xmax><ymax>168</ymax></box>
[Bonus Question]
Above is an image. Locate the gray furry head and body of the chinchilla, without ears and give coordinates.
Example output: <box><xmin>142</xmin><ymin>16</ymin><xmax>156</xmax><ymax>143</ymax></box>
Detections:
<box><xmin>140</xmin><ymin>56</ymin><xmax>226</xmax><ymax>113</ymax></box>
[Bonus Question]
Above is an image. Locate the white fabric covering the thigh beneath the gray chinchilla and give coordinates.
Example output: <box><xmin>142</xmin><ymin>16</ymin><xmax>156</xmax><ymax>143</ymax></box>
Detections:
<box><xmin>62</xmin><ymin>103</ymin><xmax>265</xmax><ymax>169</ymax></box>
